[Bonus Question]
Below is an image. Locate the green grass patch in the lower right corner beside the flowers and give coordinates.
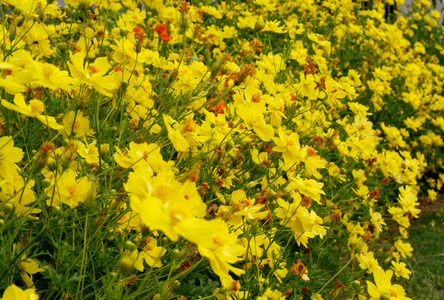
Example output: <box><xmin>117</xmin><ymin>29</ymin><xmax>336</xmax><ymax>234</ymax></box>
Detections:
<box><xmin>399</xmin><ymin>197</ymin><xmax>444</xmax><ymax>300</ymax></box>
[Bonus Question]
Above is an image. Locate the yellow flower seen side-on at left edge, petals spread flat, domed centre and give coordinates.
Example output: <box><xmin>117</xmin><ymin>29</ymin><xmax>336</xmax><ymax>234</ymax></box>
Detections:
<box><xmin>2</xmin><ymin>94</ymin><xmax>63</xmax><ymax>130</ymax></box>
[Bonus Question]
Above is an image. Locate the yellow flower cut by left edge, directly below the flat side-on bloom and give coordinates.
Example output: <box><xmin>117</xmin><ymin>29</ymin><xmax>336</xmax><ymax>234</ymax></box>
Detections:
<box><xmin>0</xmin><ymin>136</ymin><xmax>23</xmax><ymax>181</ymax></box>
